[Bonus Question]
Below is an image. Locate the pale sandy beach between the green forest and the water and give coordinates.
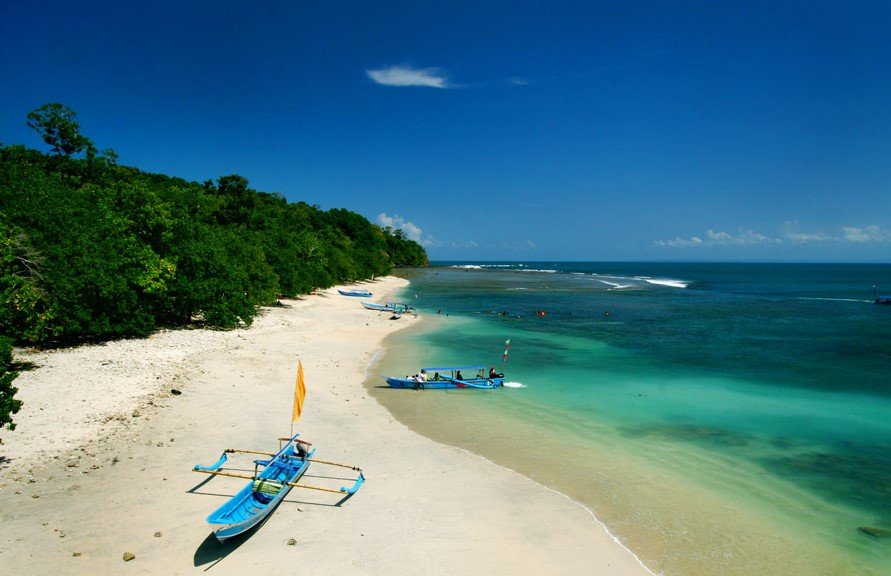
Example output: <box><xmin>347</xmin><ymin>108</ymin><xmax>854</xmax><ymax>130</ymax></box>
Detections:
<box><xmin>0</xmin><ymin>278</ymin><xmax>647</xmax><ymax>575</ymax></box>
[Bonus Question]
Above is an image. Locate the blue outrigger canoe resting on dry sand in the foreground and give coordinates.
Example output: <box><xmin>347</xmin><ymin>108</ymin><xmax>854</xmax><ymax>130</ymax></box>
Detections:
<box><xmin>193</xmin><ymin>434</ymin><xmax>365</xmax><ymax>542</ymax></box>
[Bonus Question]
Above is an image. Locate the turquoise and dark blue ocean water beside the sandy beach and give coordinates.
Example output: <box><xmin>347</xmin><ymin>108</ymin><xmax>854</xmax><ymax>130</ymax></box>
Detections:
<box><xmin>368</xmin><ymin>262</ymin><xmax>891</xmax><ymax>575</ymax></box>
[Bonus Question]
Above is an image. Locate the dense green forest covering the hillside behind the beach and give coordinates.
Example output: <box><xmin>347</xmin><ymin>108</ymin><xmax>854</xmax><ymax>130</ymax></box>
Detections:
<box><xmin>0</xmin><ymin>104</ymin><xmax>428</xmax><ymax>426</ymax></box>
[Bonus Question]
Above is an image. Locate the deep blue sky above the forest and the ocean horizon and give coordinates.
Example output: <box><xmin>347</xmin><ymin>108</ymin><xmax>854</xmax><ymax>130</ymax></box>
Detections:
<box><xmin>0</xmin><ymin>0</ymin><xmax>891</xmax><ymax>262</ymax></box>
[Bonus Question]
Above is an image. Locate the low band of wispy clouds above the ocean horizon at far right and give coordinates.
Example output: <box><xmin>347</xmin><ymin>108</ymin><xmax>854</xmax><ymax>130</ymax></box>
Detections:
<box><xmin>655</xmin><ymin>221</ymin><xmax>891</xmax><ymax>248</ymax></box>
